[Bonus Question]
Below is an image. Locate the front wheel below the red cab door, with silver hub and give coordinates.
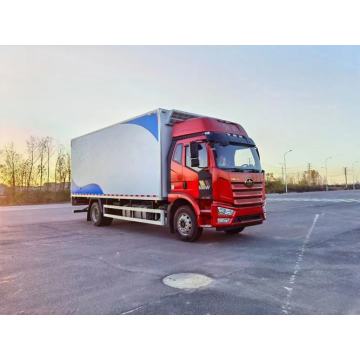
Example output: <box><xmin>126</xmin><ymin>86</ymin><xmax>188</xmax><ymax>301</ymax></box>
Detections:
<box><xmin>174</xmin><ymin>206</ymin><xmax>202</xmax><ymax>242</ymax></box>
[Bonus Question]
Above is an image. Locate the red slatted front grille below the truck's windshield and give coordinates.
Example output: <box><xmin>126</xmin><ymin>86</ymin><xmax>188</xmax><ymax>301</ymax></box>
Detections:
<box><xmin>231</xmin><ymin>182</ymin><xmax>263</xmax><ymax>207</ymax></box>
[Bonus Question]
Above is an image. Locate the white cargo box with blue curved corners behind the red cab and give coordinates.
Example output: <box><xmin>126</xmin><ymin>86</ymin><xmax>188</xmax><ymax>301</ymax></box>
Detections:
<box><xmin>71</xmin><ymin>109</ymin><xmax>172</xmax><ymax>199</ymax></box>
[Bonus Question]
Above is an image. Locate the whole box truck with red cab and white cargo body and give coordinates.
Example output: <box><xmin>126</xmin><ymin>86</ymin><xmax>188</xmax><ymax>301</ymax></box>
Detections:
<box><xmin>71</xmin><ymin>109</ymin><xmax>265</xmax><ymax>241</ymax></box>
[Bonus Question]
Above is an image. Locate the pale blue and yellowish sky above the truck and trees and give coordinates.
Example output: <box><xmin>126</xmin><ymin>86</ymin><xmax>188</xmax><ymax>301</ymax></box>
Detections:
<box><xmin>0</xmin><ymin>46</ymin><xmax>360</xmax><ymax>183</ymax></box>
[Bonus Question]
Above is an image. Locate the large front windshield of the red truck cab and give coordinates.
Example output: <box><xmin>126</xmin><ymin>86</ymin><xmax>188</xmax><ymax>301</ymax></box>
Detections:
<box><xmin>213</xmin><ymin>143</ymin><xmax>261</xmax><ymax>172</ymax></box>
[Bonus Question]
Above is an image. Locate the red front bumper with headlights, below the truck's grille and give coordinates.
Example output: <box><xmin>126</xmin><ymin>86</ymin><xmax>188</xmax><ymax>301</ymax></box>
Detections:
<box><xmin>211</xmin><ymin>203</ymin><xmax>266</xmax><ymax>228</ymax></box>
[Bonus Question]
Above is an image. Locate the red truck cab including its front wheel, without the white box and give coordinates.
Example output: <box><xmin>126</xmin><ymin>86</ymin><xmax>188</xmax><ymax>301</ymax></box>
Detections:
<box><xmin>168</xmin><ymin>117</ymin><xmax>265</xmax><ymax>241</ymax></box>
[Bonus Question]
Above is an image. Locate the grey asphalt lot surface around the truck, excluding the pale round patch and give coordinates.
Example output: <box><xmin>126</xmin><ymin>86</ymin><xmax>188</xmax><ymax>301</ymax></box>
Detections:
<box><xmin>0</xmin><ymin>191</ymin><xmax>360</xmax><ymax>314</ymax></box>
